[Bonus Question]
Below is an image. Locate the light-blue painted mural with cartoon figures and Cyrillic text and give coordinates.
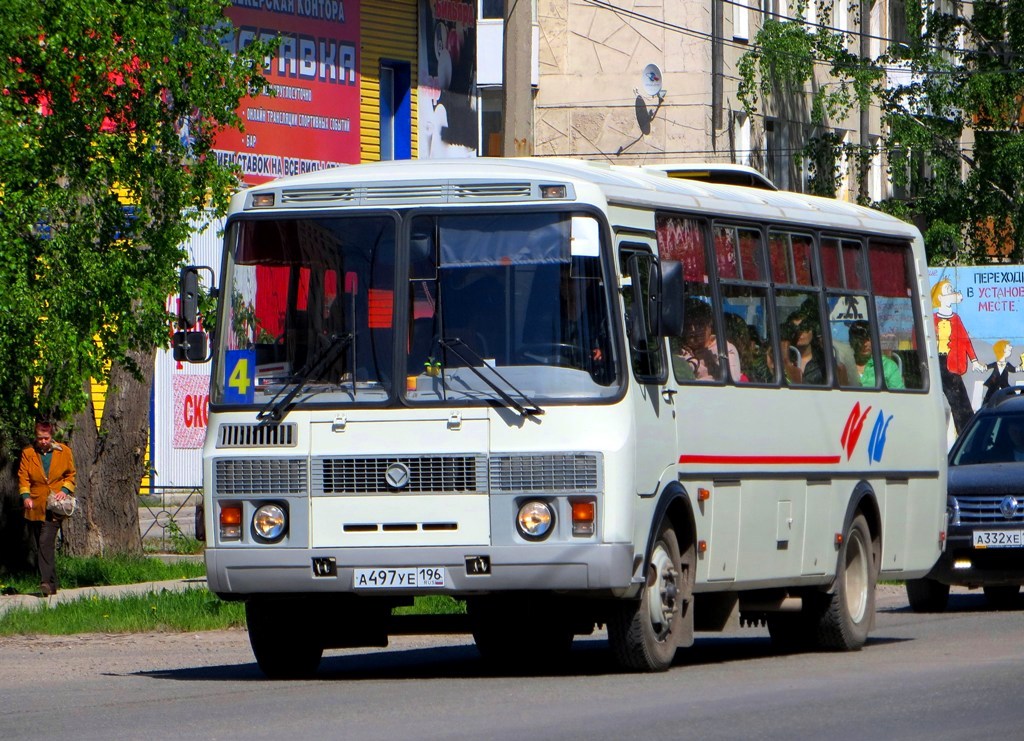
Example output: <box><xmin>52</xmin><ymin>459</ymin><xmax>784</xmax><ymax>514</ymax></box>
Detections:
<box><xmin>928</xmin><ymin>265</ymin><xmax>1024</xmax><ymax>433</ymax></box>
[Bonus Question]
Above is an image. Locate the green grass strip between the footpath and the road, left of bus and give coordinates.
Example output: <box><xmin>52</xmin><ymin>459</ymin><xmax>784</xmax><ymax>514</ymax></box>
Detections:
<box><xmin>0</xmin><ymin>589</ymin><xmax>246</xmax><ymax>636</ymax></box>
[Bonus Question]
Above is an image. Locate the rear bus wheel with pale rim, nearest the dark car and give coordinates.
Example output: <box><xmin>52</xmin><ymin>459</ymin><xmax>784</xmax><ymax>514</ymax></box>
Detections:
<box><xmin>811</xmin><ymin>514</ymin><xmax>878</xmax><ymax>651</ymax></box>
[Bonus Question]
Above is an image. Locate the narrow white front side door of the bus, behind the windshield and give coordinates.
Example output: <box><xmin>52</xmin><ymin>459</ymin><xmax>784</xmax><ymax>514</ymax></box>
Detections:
<box><xmin>618</xmin><ymin>243</ymin><xmax>678</xmax><ymax>496</ymax></box>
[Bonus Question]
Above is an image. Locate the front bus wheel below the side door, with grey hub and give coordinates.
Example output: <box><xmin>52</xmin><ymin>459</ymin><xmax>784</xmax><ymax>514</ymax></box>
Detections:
<box><xmin>608</xmin><ymin>524</ymin><xmax>693</xmax><ymax>671</ymax></box>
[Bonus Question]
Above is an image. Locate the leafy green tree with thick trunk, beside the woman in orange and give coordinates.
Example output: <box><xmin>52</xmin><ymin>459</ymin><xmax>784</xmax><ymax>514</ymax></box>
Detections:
<box><xmin>0</xmin><ymin>0</ymin><xmax>267</xmax><ymax>555</ymax></box>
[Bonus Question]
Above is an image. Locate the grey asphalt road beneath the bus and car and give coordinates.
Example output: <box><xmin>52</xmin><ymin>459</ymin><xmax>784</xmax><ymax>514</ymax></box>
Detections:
<box><xmin>0</xmin><ymin>586</ymin><xmax>1024</xmax><ymax>741</ymax></box>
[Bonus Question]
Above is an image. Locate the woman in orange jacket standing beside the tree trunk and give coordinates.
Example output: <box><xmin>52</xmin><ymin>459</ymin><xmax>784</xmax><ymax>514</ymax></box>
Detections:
<box><xmin>17</xmin><ymin>422</ymin><xmax>75</xmax><ymax>597</ymax></box>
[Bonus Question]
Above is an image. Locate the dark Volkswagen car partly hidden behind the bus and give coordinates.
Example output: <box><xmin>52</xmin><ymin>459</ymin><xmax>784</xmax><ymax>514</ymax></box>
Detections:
<box><xmin>906</xmin><ymin>387</ymin><xmax>1024</xmax><ymax>612</ymax></box>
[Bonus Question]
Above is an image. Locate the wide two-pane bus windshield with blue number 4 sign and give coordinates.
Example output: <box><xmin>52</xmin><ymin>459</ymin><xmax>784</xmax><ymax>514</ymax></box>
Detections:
<box><xmin>211</xmin><ymin>211</ymin><xmax>617</xmax><ymax>416</ymax></box>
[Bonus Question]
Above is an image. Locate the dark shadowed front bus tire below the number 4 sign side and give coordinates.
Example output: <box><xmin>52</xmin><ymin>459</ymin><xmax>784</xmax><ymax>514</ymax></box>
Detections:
<box><xmin>246</xmin><ymin>600</ymin><xmax>324</xmax><ymax>680</ymax></box>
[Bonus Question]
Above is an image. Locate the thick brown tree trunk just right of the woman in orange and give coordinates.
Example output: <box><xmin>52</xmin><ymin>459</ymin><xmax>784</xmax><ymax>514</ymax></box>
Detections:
<box><xmin>63</xmin><ymin>350</ymin><xmax>156</xmax><ymax>556</ymax></box>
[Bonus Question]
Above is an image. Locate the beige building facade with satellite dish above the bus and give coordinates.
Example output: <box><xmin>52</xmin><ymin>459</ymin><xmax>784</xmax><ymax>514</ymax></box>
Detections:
<box><xmin>535</xmin><ymin>0</ymin><xmax>902</xmax><ymax>201</ymax></box>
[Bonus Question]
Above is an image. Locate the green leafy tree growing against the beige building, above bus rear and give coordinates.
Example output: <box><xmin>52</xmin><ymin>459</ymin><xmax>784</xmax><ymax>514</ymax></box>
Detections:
<box><xmin>739</xmin><ymin>0</ymin><xmax>1024</xmax><ymax>264</ymax></box>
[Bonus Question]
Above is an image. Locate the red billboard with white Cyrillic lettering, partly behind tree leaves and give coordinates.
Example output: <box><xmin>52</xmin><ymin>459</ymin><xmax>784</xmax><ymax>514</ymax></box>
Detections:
<box><xmin>215</xmin><ymin>0</ymin><xmax>359</xmax><ymax>184</ymax></box>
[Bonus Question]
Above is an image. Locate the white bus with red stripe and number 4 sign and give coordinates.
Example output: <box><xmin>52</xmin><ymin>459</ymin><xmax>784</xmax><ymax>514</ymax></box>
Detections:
<box><xmin>176</xmin><ymin>159</ymin><xmax>946</xmax><ymax>677</ymax></box>
